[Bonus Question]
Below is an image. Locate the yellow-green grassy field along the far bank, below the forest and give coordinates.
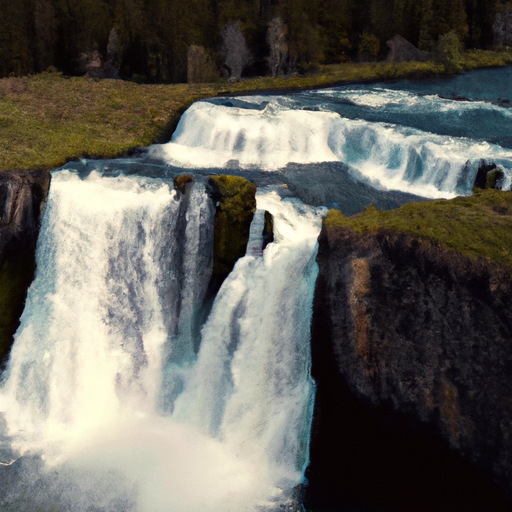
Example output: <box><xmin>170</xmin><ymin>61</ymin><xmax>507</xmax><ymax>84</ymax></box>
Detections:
<box><xmin>0</xmin><ymin>51</ymin><xmax>512</xmax><ymax>170</ymax></box>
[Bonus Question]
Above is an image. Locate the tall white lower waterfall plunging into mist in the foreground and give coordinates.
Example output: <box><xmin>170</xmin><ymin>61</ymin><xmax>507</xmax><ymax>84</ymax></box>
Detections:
<box><xmin>0</xmin><ymin>172</ymin><xmax>321</xmax><ymax>512</ymax></box>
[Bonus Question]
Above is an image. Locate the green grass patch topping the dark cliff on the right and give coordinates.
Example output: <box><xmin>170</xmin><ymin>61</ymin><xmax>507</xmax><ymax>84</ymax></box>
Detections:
<box><xmin>325</xmin><ymin>189</ymin><xmax>512</xmax><ymax>271</ymax></box>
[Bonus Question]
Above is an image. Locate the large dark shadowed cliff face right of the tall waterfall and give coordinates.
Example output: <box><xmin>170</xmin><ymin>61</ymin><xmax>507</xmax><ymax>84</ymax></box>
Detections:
<box><xmin>308</xmin><ymin>227</ymin><xmax>512</xmax><ymax>512</ymax></box>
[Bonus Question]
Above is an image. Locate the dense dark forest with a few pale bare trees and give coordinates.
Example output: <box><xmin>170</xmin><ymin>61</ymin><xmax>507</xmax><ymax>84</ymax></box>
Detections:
<box><xmin>0</xmin><ymin>0</ymin><xmax>510</xmax><ymax>82</ymax></box>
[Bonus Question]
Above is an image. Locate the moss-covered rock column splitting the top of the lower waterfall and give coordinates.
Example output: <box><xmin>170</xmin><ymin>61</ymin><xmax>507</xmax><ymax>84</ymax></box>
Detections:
<box><xmin>211</xmin><ymin>175</ymin><xmax>256</xmax><ymax>274</ymax></box>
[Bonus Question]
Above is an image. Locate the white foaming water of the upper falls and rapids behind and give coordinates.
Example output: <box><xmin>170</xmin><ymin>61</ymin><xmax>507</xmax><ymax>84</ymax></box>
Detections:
<box><xmin>151</xmin><ymin>96</ymin><xmax>512</xmax><ymax>198</ymax></box>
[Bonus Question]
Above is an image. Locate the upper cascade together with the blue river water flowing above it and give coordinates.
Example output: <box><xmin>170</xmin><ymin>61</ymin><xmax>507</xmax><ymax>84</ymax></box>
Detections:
<box><xmin>151</xmin><ymin>86</ymin><xmax>512</xmax><ymax>198</ymax></box>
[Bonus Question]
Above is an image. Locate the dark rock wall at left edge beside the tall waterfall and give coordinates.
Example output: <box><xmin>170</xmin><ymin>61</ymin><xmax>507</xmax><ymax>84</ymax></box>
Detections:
<box><xmin>0</xmin><ymin>170</ymin><xmax>50</xmax><ymax>361</ymax></box>
